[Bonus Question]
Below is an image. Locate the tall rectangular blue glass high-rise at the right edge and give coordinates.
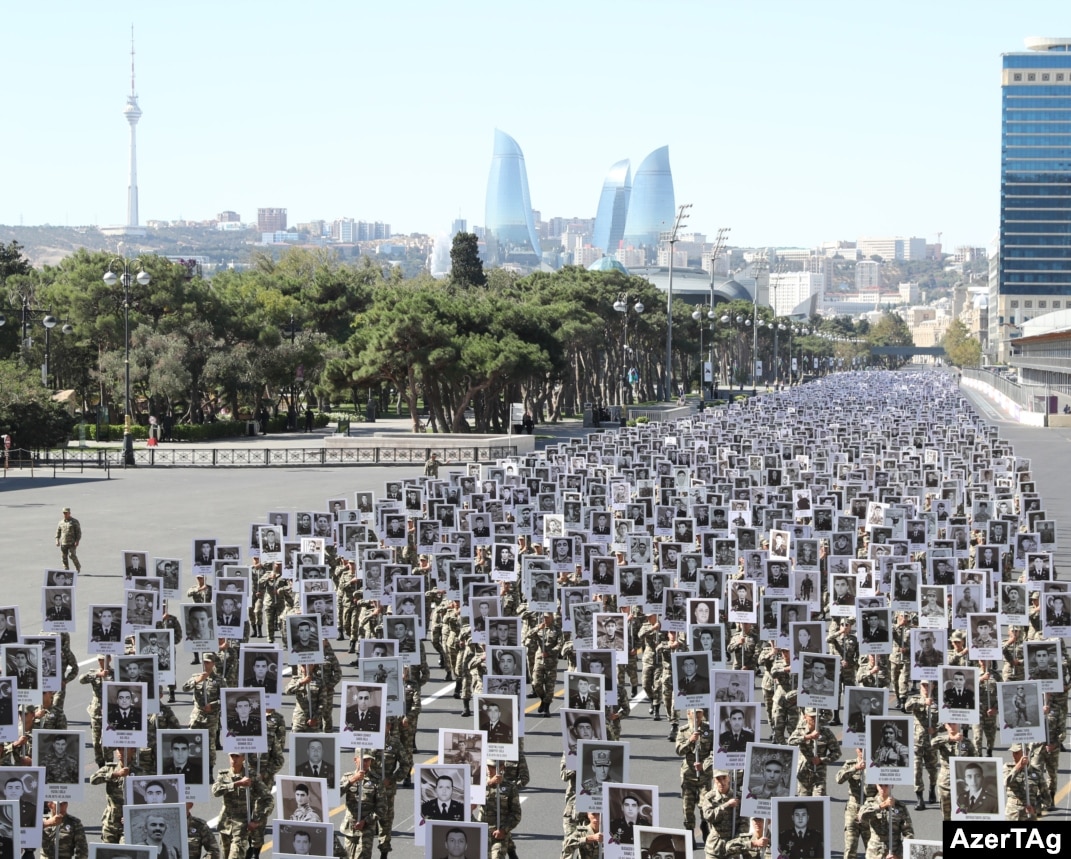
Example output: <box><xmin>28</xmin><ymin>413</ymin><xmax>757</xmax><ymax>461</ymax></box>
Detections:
<box><xmin>989</xmin><ymin>39</ymin><xmax>1071</xmax><ymax>360</ymax></box>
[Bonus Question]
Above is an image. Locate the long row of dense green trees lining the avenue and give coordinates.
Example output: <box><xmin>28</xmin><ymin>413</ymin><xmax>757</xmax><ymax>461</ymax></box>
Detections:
<box><xmin>0</xmin><ymin>233</ymin><xmax>910</xmax><ymax>439</ymax></box>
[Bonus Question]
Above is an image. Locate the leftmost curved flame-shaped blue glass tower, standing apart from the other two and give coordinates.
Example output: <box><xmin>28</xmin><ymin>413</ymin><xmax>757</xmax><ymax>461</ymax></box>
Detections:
<box><xmin>484</xmin><ymin>129</ymin><xmax>542</xmax><ymax>266</ymax></box>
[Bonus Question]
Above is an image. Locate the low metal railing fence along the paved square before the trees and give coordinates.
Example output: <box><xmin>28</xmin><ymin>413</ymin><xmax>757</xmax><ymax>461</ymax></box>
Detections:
<box><xmin>9</xmin><ymin>444</ymin><xmax>517</xmax><ymax>471</ymax></box>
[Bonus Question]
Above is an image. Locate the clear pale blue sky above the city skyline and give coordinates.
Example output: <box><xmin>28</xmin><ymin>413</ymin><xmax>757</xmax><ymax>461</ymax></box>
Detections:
<box><xmin>0</xmin><ymin>0</ymin><xmax>1071</xmax><ymax>247</ymax></box>
